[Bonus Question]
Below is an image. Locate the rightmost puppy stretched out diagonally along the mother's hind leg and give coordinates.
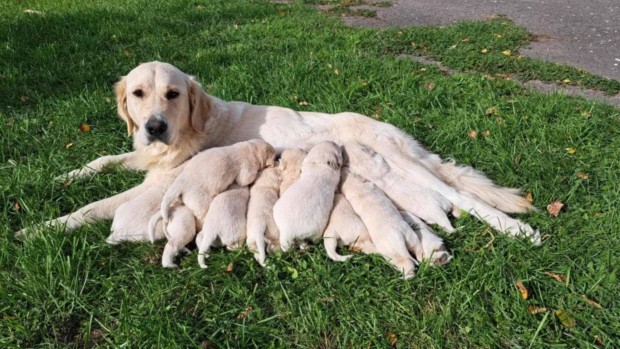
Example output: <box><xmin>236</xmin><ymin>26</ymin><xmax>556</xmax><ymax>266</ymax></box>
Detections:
<box><xmin>344</xmin><ymin>142</ymin><xmax>454</xmax><ymax>232</ymax></box>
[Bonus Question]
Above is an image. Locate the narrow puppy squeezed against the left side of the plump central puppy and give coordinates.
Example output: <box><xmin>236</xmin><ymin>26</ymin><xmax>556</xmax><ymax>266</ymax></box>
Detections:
<box><xmin>246</xmin><ymin>167</ymin><xmax>280</xmax><ymax>266</ymax></box>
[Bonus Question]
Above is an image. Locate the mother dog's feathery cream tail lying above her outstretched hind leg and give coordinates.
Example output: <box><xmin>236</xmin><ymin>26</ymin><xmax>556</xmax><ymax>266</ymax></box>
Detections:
<box><xmin>433</xmin><ymin>161</ymin><xmax>535</xmax><ymax>213</ymax></box>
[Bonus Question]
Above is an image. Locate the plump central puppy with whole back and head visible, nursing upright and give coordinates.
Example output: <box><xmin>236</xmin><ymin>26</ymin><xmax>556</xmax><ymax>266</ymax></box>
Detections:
<box><xmin>273</xmin><ymin>142</ymin><xmax>342</xmax><ymax>252</ymax></box>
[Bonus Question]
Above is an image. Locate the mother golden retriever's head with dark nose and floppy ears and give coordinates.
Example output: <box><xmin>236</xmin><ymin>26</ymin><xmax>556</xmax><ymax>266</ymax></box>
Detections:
<box><xmin>116</xmin><ymin>62</ymin><xmax>212</xmax><ymax>146</ymax></box>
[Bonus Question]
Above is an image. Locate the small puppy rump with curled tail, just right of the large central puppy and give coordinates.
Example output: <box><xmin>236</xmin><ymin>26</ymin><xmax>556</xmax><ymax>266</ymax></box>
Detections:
<box><xmin>323</xmin><ymin>194</ymin><xmax>377</xmax><ymax>262</ymax></box>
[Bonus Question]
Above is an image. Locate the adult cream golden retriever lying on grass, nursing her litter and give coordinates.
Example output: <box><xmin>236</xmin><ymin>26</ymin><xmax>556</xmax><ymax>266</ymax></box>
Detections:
<box><xmin>18</xmin><ymin>62</ymin><xmax>540</xmax><ymax>242</ymax></box>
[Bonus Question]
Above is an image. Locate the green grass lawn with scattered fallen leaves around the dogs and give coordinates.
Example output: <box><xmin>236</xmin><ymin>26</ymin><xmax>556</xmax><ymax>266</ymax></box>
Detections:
<box><xmin>0</xmin><ymin>0</ymin><xmax>620</xmax><ymax>348</ymax></box>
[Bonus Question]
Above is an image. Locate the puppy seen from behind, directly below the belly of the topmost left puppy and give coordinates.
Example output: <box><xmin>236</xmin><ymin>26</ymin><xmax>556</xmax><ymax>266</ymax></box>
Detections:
<box><xmin>196</xmin><ymin>184</ymin><xmax>250</xmax><ymax>268</ymax></box>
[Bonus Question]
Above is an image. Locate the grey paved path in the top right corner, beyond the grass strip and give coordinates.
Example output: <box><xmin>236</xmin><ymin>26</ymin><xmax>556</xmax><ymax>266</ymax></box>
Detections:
<box><xmin>345</xmin><ymin>0</ymin><xmax>620</xmax><ymax>80</ymax></box>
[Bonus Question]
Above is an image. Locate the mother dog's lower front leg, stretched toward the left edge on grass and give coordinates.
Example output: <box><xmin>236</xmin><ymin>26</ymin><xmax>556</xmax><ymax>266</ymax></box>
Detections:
<box><xmin>15</xmin><ymin>183</ymin><xmax>148</xmax><ymax>237</ymax></box>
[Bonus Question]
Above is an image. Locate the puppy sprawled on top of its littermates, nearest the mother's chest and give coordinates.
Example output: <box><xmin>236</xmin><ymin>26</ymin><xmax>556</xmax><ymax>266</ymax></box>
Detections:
<box><xmin>149</xmin><ymin>140</ymin><xmax>275</xmax><ymax>266</ymax></box>
